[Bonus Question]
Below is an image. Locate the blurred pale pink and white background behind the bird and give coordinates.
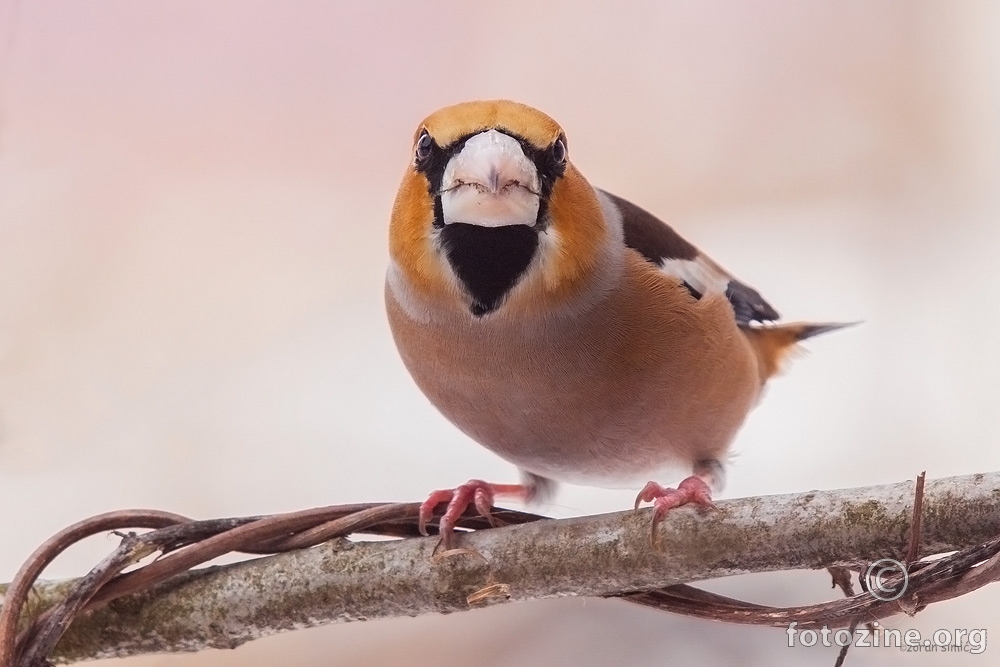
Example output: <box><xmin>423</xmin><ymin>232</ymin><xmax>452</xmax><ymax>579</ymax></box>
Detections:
<box><xmin>0</xmin><ymin>0</ymin><xmax>1000</xmax><ymax>667</ymax></box>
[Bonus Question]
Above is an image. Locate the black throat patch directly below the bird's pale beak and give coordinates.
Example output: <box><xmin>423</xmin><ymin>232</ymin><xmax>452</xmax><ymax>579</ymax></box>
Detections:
<box><xmin>441</xmin><ymin>222</ymin><xmax>538</xmax><ymax>317</ymax></box>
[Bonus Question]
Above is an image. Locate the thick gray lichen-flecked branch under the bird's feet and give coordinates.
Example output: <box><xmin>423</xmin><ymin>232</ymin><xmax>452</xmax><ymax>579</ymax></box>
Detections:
<box><xmin>0</xmin><ymin>473</ymin><xmax>1000</xmax><ymax>662</ymax></box>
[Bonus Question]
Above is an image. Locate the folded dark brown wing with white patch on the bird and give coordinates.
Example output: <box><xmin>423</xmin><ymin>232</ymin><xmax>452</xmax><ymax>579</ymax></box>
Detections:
<box><xmin>604</xmin><ymin>192</ymin><xmax>780</xmax><ymax>324</ymax></box>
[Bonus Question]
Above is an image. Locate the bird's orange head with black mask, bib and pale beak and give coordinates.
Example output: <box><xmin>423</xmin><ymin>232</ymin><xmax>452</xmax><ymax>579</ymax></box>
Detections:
<box><xmin>389</xmin><ymin>100</ymin><xmax>613</xmax><ymax>318</ymax></box>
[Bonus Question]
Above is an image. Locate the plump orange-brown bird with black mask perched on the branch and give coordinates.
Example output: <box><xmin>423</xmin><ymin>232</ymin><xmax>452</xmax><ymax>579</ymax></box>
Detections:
<box><xmin>385</xmin><ymin>100</ymin><xmax>847</xmax><ymax>548</ymax></box>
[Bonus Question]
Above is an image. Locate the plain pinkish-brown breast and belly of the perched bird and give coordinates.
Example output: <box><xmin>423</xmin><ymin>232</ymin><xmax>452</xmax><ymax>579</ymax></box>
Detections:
<box><xmin>386</xmin><ymin>251</ymin><xmax>760</xmax><ymax>485</ymax></box>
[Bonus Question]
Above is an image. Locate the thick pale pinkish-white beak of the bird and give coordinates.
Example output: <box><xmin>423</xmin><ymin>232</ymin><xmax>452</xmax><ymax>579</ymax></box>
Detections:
<box><xmin>441</xmin><ymin>130</ymin><xmax>540</xmax><ymax>227</ymax></box>
